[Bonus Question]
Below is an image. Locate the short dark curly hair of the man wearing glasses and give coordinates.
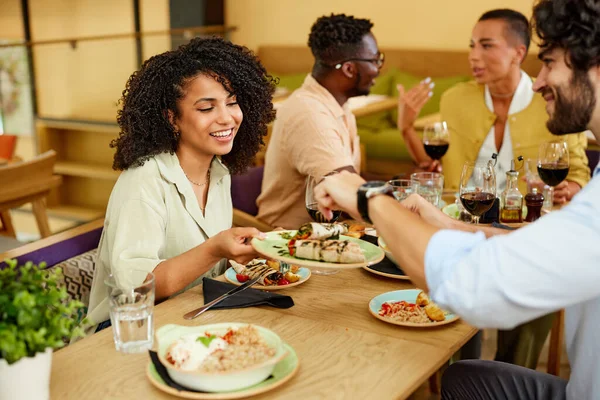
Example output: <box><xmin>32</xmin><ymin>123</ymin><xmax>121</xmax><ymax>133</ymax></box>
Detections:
<box><xmin>308</xmin><ymin>14</ymin><xmax>373</xmax><ymax>63</ymax></box>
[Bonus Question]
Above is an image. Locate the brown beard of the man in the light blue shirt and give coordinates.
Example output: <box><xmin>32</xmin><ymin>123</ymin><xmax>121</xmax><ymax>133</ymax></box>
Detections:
<box><xmin>546</xmin><ymin>70</ymin><xmax>596</xmax><ymax>135</ymax></box>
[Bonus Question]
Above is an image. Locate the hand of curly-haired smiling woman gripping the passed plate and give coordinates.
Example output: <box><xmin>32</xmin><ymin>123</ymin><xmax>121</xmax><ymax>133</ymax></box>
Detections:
<box><xmin>207</xmin><ymin>228</ymin><xmax>265</xmax><ymax>264</ymax></box>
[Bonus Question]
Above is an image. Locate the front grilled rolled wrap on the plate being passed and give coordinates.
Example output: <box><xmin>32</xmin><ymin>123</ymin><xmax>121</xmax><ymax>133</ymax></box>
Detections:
<box><xmin>288</xmin><ymin>240</ymin><xmax>365</xmax><ymax>264</ymax></box>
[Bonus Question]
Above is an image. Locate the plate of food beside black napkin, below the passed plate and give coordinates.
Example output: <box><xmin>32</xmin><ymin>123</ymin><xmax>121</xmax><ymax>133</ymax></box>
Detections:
<box><xmin>225</xmin><ymin>258</ymin><xmax>310</xmax><ymax>290</ymax></box>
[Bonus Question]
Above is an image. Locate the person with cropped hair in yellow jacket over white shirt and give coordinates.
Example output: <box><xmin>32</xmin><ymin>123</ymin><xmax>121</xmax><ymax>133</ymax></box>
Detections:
<box><xmin>403</xmin><ymin>9</ymin><xmax>590</xmax><ymax>369</ymax></box>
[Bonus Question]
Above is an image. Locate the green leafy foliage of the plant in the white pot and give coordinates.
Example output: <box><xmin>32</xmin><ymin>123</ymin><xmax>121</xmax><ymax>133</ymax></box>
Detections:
<box><xmin>0</xmin><ymin>260</ymin><xmax>83</xmax><ymax>364</ymax></box>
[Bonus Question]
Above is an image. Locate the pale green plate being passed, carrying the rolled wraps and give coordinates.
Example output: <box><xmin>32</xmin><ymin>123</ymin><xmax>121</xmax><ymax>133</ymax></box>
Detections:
<box><xmin>251</xmin><ymin>230</ymin><xmax>385</xmax><ymax>269</ymax></box>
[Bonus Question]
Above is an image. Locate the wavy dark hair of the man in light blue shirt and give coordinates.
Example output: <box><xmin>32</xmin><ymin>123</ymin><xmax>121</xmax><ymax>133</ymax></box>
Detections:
<box><xmin>531</xmin><ymin>0</ymin><xmax>600</xmax><ymax>72</ymax></box>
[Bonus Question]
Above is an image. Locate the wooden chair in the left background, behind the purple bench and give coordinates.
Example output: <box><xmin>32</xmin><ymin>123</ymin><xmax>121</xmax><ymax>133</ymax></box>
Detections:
<box><xmin>0</xmin><ymin>150</ymin><xmax>62</xmax><ymax>238</ymax></box>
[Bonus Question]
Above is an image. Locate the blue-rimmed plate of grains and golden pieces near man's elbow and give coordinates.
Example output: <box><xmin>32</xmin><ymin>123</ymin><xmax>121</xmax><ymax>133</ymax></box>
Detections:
<box><xmin>369</xmin><ymin>289</ymin><xmax>458</xmax><ymax>328</ymax></box>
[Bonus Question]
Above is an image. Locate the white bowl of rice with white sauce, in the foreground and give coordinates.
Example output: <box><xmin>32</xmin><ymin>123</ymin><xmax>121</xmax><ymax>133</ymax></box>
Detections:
<box><xmin>155</xmin><ymin>322</ymin><xmax>287</xmax><ymax>392</ymax></box>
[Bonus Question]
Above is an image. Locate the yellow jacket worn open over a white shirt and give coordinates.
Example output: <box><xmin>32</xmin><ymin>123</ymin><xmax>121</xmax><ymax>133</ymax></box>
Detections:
<box><xmin>440</xmin><ymin>81</ymin><xmax>590</xmax><ymax>195</ymax></box>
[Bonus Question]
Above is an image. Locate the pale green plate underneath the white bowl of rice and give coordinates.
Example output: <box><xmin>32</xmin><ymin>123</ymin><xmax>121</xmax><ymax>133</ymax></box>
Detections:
<box><xmin>146</xmin><ymin>343</ymin><xmax>300</xmax><ymax>400</ymax></box>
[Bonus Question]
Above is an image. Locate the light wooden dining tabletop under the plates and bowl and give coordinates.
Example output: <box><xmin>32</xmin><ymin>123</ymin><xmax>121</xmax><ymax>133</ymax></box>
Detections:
<box><xmin>51</xmin><ymin>269</ymin><xmax>476</xmax><ymax>400</ymax></box>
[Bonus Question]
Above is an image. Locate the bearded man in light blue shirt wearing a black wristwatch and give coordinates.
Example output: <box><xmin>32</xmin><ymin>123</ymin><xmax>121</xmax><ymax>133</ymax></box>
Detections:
<box><xmin>316</xmin><ymin>0</ymin><xmax>600</xmax><ymax>400</ymax></box>
